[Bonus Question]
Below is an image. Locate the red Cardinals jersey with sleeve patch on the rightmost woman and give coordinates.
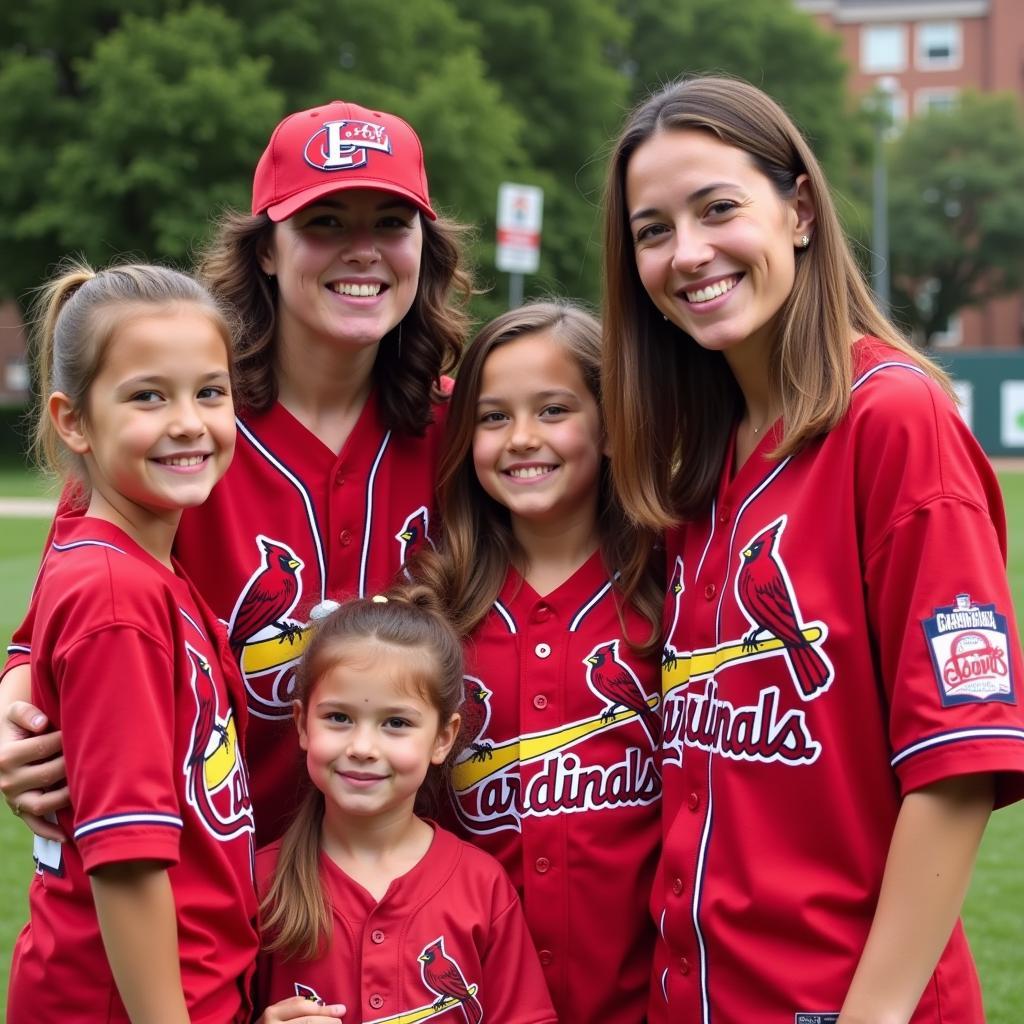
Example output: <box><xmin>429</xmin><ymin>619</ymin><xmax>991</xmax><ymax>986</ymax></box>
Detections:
<box><xmin>651</xmin><ymin>339</ymin><xmax>1024</xmax><ymax>1024</ymax></box>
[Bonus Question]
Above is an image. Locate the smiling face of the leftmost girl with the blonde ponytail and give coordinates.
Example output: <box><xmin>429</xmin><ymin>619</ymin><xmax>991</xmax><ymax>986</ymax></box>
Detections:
<box><xmin>58</xmin><ymin>304</ymin><xmax>234</xmax><ymax>549</ymax></box>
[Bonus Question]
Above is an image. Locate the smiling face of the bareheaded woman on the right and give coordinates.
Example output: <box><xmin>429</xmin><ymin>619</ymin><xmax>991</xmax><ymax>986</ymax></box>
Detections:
<box><xmin>626</xmin><ymin>129</ymin><xmax>813</xmax><ymax>366</ymax></box>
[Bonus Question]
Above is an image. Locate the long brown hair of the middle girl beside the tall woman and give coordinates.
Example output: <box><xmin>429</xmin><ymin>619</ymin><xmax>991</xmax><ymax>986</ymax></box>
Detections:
<box><xmin>410</xmin><ymin>299</ymin><xmax>664</xmax><ymax>653</ymax></box>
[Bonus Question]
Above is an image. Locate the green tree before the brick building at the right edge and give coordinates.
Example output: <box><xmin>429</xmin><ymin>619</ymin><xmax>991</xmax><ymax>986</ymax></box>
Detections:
<box><xmin>889</xmin><ymin>92</ymin><xmax>1024</xmax><ymax>345</ymax></box>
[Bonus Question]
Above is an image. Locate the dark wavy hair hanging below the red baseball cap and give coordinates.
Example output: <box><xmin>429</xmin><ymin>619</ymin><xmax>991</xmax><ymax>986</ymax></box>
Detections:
<box><xmin>197</xmin><ymin>210</ymin><xmax>473</xmax><ymax>435</ymax></box>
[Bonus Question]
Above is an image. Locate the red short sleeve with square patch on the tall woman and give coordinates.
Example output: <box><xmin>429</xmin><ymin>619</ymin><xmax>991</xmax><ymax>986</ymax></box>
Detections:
<box><xmin>861</xmin><ymin>372</ymin><xmax>1024</xmax><ymax>806</ymax></box>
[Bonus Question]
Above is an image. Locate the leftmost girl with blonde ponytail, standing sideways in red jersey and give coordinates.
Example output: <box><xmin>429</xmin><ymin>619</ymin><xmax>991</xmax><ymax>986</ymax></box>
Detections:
<box><xmin>7</xmin><ymin>265</ymin><xmax>257</xmax><ymax>1024</ymax></box>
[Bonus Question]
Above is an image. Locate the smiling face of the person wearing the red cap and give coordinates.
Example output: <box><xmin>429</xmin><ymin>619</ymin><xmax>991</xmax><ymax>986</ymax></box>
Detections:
<box><xmin>259</xmin><ymin>188</ymin><xmax>423</xmax><ymax>361</ymax></box>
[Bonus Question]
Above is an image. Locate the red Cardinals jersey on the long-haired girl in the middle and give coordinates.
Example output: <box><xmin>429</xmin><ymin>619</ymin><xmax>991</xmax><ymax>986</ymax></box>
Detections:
<box><xmin>452</xmin><ymin>554</ymin><xmax>662</xmax><ymax>1024</ymax></box>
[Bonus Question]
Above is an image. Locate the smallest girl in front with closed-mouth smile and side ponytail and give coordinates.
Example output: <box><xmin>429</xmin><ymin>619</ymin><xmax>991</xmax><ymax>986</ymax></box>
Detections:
<box><xmin>256</xmin><ymin>587</ymin><xmax>556</xmax><ymax>1024</ymax></box>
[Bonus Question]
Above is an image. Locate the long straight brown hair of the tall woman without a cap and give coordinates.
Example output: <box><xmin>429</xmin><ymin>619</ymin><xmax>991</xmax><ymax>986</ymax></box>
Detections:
<box><xmin>603</xmin><ymin>76</ymin><xmax>952</xmax><ymax>529</ymax></box>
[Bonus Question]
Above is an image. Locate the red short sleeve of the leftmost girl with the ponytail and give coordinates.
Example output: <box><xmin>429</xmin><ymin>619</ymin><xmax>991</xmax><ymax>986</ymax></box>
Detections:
<box><xmin>54</xmin><ymin>626</ymin><xmax>183</xmax><ymax>871</ymax></box>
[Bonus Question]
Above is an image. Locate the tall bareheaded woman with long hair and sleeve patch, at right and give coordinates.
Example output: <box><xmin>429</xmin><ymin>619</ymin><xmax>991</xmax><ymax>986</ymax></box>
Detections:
<box><xmin>604</xmin><ymin>77</ymin><xmax>1024</xmax><ymax>1024</ymax></box>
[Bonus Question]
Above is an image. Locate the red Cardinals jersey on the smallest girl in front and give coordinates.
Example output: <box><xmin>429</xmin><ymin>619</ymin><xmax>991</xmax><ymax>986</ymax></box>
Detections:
<box><xmin>256</xmin><ymin>827</ymin><xmax>556</xmax><ymax>1024</ymax></box>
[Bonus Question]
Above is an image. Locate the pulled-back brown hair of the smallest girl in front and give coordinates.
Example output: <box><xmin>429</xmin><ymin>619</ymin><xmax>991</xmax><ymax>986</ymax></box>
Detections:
<box><xmin>260</xmin><ymin>585</ymin><xmax>463</xmax><ymax>959</ymax></box>
